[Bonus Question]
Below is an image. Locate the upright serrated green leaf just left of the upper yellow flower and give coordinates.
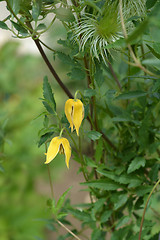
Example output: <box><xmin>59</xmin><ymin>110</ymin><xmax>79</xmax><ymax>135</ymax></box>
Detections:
<box><xmin>43</xmin><ymin>76</ymin><xmax>56</xmax><ymax>111</ymax></box>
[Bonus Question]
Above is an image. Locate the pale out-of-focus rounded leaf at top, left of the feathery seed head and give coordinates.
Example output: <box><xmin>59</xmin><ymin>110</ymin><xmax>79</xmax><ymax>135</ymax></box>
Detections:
<box><xmin>53</xmin><ymin>7</ymin><xmax>75</xmax><ymax>22</ymax></box>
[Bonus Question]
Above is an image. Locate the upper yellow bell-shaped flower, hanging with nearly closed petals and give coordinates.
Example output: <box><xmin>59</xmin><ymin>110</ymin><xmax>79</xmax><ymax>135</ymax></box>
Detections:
<box><xmin>65</xmin><ymin>99</ymin><xmax>84</xmax><ymax>136</ymax></box>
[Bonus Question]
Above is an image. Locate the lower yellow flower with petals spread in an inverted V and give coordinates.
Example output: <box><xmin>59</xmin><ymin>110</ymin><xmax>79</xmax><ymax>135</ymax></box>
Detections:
<box><xmin>45</xmin><ymin>137</ymin><xmax>71</xmax><ymax>168</ymax></box>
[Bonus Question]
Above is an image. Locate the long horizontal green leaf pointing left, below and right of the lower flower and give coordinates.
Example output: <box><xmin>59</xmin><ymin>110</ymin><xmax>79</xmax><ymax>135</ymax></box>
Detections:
<box><xmin>81</xmin><ymin>179</ymin><xmax>121</xmax><ymax>191</ymax></box>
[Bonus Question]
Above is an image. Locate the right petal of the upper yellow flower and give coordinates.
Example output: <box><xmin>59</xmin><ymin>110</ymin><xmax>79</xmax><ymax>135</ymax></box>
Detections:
<box><xmin>73</xmin><ymin>99</ymin><xmax>84</xmax><ymax>136</ymax></box>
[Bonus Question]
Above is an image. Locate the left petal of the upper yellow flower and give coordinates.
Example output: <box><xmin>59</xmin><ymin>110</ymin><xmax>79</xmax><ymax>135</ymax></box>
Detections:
<box><xmin>65</xmin><ymin>99</ymin><xmax>74</xmax><ymax>132</ymax></box>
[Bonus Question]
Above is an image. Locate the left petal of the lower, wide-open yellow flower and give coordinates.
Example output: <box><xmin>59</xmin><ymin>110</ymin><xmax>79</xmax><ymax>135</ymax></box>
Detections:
<box><xmin>45</xmin><ymin>137</ymin><xmax>61</xmax><ymax>164</ymax></box>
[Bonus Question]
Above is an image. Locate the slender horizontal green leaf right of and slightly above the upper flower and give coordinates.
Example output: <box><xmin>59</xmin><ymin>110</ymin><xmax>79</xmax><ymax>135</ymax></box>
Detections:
<box><xmin>115</xmin><ymin>90</ymin><xmax>147</xmax><ymax>100</ymax></box>
